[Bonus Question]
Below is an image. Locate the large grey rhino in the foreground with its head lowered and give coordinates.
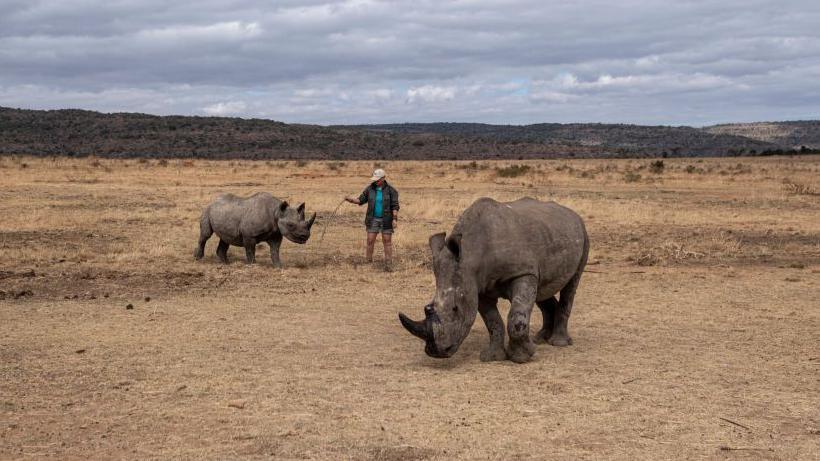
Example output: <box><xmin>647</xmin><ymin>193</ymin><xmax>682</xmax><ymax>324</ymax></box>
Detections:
<box><xmin>399</xmin><ymin>198</ymin><xmax>589</xmax><ymax>363</ymax></box>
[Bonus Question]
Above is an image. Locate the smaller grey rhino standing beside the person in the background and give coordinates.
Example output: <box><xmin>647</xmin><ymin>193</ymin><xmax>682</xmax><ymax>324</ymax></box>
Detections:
<box><xmin>194</xmin><ymin>192</ymin><xmax>316</xmax><ymax>267</ymax></box>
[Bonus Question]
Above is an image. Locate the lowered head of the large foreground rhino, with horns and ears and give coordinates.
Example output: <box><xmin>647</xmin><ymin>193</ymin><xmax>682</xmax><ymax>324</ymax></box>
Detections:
<box><xmin>399</xmin><ymin>232</ymin><xmax>478</xmax><ymax>358</ymax></box>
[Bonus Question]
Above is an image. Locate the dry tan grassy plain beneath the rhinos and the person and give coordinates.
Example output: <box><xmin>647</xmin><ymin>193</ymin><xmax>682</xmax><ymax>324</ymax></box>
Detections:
<box><xmin>0</xmin><ymin>156</ymin><xmax>820</xmax><ymax>460</ymax></box>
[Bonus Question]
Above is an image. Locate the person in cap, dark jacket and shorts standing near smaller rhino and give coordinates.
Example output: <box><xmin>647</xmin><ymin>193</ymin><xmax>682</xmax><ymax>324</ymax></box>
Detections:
<box><xmin>344</xmin><ymin>168</ymin><xmax>399</xmax><ymax>272</ymax></box>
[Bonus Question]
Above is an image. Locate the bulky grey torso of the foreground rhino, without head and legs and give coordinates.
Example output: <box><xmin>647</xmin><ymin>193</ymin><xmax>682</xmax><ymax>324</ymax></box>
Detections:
<box><xmin>453</xmin><ymin>198</ymin><xmax>587</xmax><ymax>298</ymax></box>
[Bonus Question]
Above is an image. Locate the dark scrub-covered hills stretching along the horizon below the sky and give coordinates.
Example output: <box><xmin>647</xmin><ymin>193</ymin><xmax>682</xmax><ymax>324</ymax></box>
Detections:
<box><xmin>0</xmin><ymin>107</ymin><xmax>820</xmax><ymax>159</ymax></box>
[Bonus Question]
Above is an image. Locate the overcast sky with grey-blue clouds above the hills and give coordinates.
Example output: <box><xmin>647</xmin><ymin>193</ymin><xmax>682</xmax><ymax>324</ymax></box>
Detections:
<box><xmin>0</xmin><ymin>0</ymin><xmax>820</xmax><ymax>125</ymax></box>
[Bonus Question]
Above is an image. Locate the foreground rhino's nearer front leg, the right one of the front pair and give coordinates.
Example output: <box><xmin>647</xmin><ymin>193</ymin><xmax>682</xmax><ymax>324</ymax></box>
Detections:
<box><xmin>507</xmin><ymin>275</ymin><xmax>538</xmax><ymax>363</ymax></box>
